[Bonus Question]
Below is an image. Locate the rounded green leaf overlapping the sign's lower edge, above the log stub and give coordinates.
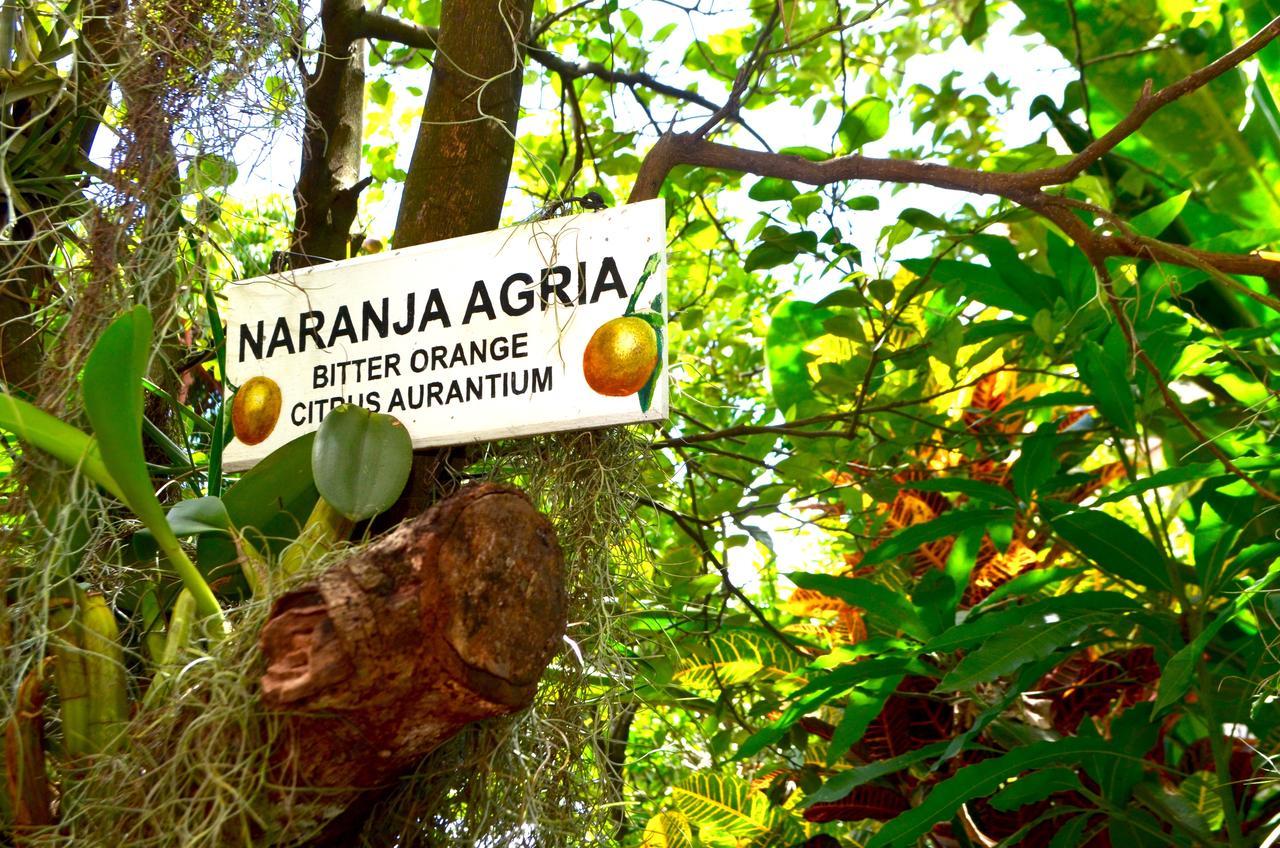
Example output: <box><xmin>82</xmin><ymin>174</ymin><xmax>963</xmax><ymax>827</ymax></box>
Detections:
<box><xmin>311</xmin><ymin>404</ymin><xmax>413</xmax><ymax>521</ymax></box>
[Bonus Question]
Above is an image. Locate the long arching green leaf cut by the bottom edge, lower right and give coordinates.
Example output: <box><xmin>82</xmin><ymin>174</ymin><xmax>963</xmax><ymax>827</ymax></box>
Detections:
<box><xmin>865</xmin><ymin>738</ymin><xmax>1115</xmax><ymax>848</ymax></box>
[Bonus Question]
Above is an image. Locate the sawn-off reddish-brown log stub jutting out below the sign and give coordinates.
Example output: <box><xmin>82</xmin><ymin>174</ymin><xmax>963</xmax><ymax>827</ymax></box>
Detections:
<box><xmin>260</xmin><ymin>483</ymin><xmax>566</xmax><ymax>788</ymax></box>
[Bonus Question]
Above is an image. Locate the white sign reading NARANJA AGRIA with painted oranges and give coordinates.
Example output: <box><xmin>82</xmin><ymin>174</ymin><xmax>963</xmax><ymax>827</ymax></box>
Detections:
<box><xmin>224</xmin><ymin>200</ymin><xmax>667</xmax><ymax>470</ymax></box>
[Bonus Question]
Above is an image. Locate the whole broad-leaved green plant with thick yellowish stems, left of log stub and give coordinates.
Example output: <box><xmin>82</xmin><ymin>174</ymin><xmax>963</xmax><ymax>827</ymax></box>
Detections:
<box><xmin>0</xmin><ymin>306</ymin><xmax>412</xmax><ymax>829</ymax></box>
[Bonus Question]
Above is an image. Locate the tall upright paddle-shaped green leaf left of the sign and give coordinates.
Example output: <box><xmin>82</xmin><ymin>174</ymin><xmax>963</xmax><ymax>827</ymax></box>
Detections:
<box><xmin>81</xmin><ymin>306</ymin><xmax>221</xmax><ymax>620</ymax></box>
